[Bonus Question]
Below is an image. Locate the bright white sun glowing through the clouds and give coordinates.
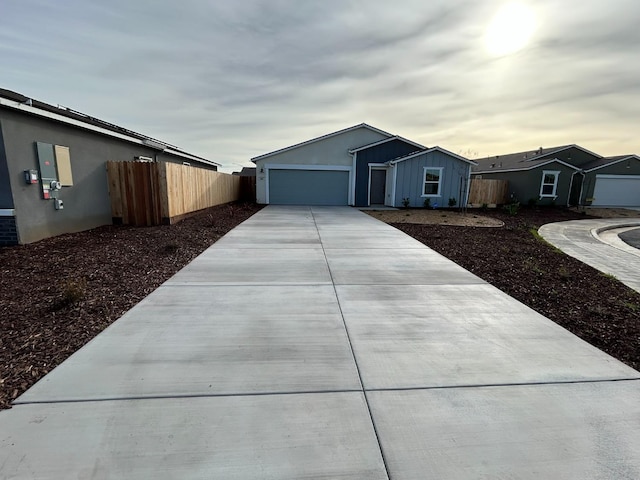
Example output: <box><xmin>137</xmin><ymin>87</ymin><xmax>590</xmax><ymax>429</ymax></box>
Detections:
<box><xmin>485</xmin><ymin>3</ymin><xmax>536</xmax><ymax>57</ymax></box>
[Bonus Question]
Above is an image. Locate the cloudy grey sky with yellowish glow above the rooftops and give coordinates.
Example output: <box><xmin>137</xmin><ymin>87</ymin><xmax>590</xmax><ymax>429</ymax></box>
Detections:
<box><xmin>0</xmin><ymin>0</ymin><xmax>640</xmax><ymax>172</ymax></box>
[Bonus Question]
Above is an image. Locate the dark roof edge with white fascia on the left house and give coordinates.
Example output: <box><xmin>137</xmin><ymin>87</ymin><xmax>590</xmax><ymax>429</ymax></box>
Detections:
<box><xmin>0</xmin><ymin>88</ymin><xmax>222</xmax><ymax>167</ymax></box>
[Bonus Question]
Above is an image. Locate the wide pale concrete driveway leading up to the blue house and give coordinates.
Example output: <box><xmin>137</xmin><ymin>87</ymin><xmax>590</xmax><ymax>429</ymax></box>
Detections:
<box><xmin>0</xmin><ymin>206</ymin><xmax>640</xmax><ymax>480</ymax></box>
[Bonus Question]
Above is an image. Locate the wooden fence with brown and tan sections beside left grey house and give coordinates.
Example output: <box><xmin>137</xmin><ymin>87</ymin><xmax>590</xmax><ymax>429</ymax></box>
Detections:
<box><xmin>107</xmin><ymin>162</ymin><xmax>240</xmax><ymax>226</ymax></box>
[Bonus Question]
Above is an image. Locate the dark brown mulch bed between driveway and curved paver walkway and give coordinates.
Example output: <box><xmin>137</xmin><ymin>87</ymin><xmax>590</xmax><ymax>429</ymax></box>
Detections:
<box><xmin>393</xmin><ymin>208</ymin><xmax>640</xmax><ymax>370</ymax></box>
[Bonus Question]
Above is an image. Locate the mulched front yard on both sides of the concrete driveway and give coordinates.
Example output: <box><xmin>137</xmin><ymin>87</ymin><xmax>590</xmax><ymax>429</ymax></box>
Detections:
<box><xmin>0</xmin><ymin>204</ymin><xmax>640</xmax><ymax>409</ymax></box>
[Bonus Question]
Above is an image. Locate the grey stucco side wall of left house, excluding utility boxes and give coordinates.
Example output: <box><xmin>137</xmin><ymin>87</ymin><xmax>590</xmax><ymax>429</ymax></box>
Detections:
<box><xmin>0</xmin><ymin>109</ymin><xmax>162</xmax><ymax>243</ymax></box>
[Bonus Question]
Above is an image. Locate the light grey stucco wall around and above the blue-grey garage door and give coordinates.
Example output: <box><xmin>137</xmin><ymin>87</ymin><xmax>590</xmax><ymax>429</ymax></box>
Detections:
<box><xmin>256</xmin><ymin>127</ymin><xmax>388</xmax><ymax>204</ymax></box>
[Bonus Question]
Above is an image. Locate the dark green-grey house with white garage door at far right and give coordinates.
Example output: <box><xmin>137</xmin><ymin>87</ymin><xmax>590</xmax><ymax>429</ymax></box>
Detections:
<box><xmin>471</xmin><ymin>145</ymin><xmax>640</xmax><ymax>207</ymax></box>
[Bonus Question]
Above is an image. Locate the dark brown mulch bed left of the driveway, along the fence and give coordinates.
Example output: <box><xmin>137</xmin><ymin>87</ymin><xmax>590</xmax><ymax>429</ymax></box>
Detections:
<box><xmin>0</xmin><ymin>204</ymin><xmax>261</xmax><ymax>409</ymax></box>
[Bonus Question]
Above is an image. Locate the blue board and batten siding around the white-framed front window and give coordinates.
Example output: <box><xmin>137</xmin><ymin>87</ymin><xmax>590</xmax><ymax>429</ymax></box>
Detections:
<box><xmin>390</xmin><ymin>150</ymin><xmax>471</xmax><ymax>207</ymax></box>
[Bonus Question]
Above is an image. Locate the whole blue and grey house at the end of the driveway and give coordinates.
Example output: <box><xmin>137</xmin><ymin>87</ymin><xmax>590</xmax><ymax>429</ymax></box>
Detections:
<box><xmin>251</xmin><ymin>123</ymin><xmax>475</xmax><ymax>207</ymax></box>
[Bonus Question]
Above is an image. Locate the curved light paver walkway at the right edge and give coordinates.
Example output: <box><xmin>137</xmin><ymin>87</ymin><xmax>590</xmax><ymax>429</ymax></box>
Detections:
<box><xmin>539</xmin><ymin>218</ymin><xmax>640</xmax><ymax>292</ymax></box>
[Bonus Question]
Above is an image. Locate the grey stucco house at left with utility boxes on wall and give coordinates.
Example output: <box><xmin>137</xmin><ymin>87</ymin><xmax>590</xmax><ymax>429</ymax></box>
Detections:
<box><xmin>0</xmin><ymin>89</ymin><xmax>219</xmax><ymax>245</ymax></box>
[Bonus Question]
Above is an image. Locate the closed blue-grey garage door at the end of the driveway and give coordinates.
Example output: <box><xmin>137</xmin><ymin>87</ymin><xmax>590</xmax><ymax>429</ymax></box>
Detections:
<box><xmin>269</xmin><ymin>169</ymin><xmax>349</xmax><ymax>205</ymax></box>
